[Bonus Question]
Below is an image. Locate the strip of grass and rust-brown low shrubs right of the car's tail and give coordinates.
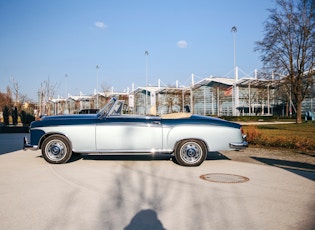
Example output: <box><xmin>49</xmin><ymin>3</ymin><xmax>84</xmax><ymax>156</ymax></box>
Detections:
<box><xmin>243</xmin><ymin>122</ymin><xmax>315</xmax><ymax>151</ymax></box>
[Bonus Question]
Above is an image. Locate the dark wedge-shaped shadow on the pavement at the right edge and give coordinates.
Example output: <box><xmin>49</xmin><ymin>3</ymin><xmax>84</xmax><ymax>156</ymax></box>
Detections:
<box><xmin>251</xmin><ymin>156</ymin><xmax>315</xmax><ymax>181</ymax></box>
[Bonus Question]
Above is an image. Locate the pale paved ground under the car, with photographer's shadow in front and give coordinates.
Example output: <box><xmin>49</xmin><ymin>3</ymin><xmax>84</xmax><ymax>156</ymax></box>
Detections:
<box><xmin>0</xmin><ymin>134</ymin><xmax>315</xmax><ymax>230</ymax></box>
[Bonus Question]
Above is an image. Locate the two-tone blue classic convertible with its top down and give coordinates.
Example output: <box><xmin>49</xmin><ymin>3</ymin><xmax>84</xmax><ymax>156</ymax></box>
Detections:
<box><xmin>24</xmin><ymin>98</ymin><xmax>248</xmax><ymax>166</ymax></box>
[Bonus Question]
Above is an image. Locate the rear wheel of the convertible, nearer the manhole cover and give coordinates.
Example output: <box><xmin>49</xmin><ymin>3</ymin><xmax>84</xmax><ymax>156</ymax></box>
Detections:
<box><xmin>175</xmin><ymin>140</ymin><xmax>207</xmax><ymax>166</ymax></box>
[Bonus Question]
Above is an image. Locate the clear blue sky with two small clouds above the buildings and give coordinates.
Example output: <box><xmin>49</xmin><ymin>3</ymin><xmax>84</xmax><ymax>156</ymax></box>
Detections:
<box><xmin>0</xmin><ymin>0</ymin><xmax>274</xmax><ymax>101</ymax></box>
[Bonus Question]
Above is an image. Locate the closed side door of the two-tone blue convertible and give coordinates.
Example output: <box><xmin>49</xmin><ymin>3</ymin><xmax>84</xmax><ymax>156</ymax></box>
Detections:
<box><xmin>96</xmin><ymin>115</ymin><xmax>163</xmax><ymax>153</ymax></box>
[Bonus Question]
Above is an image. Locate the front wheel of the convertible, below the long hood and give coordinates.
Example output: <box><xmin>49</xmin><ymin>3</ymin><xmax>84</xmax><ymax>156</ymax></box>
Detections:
<box><xmin>42</xmin><ymin>135</ymin><xmax>72</xmax><ymax>164</ymax></box>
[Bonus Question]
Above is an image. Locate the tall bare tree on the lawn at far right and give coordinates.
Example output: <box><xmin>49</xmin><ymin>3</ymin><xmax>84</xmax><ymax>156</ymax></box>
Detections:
<box><xmin>255</xmin><ymin>0</ymin><xmax>315</xmax><ymax>123</ymax></box>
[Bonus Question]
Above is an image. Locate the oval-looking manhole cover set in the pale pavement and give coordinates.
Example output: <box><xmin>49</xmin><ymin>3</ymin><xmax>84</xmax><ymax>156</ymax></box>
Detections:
<box><xmin>200</xmin><ymin>173</ymin><xmax>249</xmax><ymax>183</ymax></box>
